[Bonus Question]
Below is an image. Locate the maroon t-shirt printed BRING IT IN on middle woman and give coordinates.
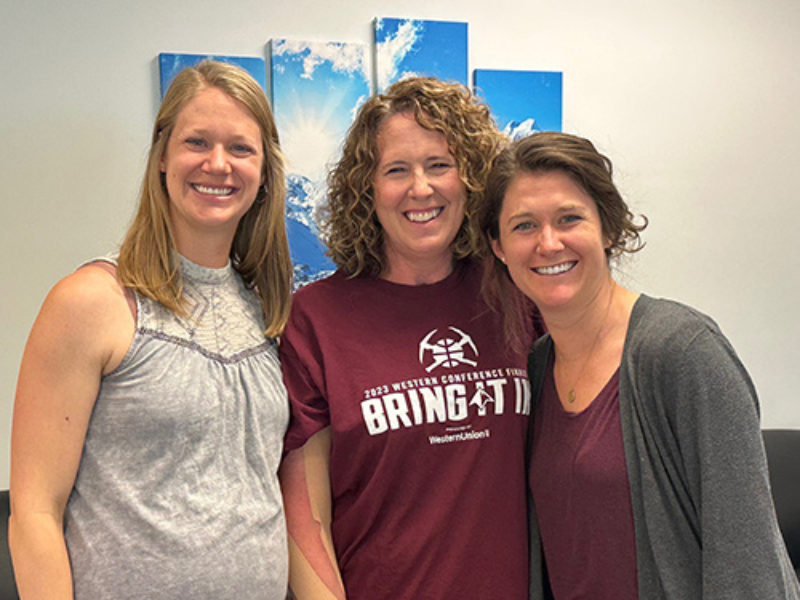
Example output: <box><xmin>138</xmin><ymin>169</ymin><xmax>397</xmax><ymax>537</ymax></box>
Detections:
<box><xmin>281</xmin><ymin>264</ymin><xmax>530</xmax><ymax>600</ymax></box>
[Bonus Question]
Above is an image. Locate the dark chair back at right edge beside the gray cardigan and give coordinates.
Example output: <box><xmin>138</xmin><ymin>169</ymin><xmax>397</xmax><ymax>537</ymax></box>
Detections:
<box><xmin>762</xmin><ymin>429</ymin><xmax>800</xmax><ymax>573</ymax></box>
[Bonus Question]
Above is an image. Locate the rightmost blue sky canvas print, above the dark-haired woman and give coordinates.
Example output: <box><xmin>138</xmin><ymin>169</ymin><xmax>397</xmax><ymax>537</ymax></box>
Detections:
<box><xmin>475</xmin><ymin>69</ymin><xmax>563</xmax><ymax>139</ymax></box>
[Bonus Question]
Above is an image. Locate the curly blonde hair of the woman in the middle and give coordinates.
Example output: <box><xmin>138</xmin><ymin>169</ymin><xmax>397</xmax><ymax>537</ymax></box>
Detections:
<box><xmin>320</xmin><ymin>77</ymin><xmax>505</xmax><ymax>277</ymax></box>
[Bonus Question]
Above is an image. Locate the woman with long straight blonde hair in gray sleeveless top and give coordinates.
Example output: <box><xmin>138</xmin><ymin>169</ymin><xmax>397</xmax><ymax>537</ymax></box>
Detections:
<box><xmin>9</xmin><ymin>61</ymin><xmax>291</xmax><ymax>600</ymax></box>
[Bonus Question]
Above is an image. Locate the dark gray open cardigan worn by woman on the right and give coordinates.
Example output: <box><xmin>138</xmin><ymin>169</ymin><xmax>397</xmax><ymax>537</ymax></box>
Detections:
<box><xmin>528</xmin><ymin>295</ymin><xmax>800</xmax><ymax>600</ymax></box>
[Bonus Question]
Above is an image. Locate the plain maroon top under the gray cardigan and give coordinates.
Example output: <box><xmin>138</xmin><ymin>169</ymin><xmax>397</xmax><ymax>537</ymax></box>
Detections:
<box><xmin>530</xmin><ymin>359</ymin><xmax>638</xmax><ymax>600</ymax></box>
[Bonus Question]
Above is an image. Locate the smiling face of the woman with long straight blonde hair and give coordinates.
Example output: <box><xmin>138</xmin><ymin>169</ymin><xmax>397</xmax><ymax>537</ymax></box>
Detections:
<box><xmin>160</xmin><ymin>87</ymin><xmax>264</xmax><ymax>255</ymax></box>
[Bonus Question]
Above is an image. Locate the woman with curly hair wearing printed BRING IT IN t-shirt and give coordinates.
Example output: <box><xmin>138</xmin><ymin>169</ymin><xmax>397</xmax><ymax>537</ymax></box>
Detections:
<box><xmin>280</xmin><ymin>78</ymin><xmax>544</xmax><ymax>600</ymax></box>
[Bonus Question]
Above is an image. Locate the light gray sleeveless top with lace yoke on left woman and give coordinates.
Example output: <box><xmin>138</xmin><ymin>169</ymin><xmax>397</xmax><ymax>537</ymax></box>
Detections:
<box><xmin>65</xmin><ymin>258</ymin><xmax>289</xmax><ymax>600</ymax></box>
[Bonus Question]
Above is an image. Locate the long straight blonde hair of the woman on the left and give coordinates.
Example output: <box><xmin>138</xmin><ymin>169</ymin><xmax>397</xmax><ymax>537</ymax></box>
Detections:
<box><xmin>118</xmin><ymin>60</ymin><xmax>292</xmax><ymax>336</ymax></box>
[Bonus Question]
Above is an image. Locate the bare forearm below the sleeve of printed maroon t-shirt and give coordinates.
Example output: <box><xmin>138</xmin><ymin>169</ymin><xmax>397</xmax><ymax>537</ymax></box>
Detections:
<box><xmin>280</xmin><ymin>427</ymin><xmax>345</xmax><ymax>600</ymax></box>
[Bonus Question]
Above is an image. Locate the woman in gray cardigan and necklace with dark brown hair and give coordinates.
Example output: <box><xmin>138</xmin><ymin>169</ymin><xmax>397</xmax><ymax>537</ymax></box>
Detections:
<box><xmin>482</xmin><ymin>132</ymin><xmax>800</xmax><ymax>600</ymax></box>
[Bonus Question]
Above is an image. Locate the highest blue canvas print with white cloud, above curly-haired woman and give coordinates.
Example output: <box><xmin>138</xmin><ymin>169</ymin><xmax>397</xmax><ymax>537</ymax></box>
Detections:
<box><xmin>374</xmin><ymin>18</ymin><xmax>469</xmax><ymax>92</ymax></box>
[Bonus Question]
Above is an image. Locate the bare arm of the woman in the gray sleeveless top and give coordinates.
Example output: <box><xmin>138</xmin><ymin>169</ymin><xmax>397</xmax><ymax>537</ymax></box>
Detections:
<box><xmin>9</xmin><ymin>267</ymin><xmax>134</xmax><ymax>600</ymax></box>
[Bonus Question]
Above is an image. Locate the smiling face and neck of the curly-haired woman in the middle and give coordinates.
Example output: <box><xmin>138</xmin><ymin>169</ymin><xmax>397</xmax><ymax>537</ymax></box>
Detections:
<box><xmin>373</xmin><ymin>113</ymin><xmax>466</xmax><ymax>283</ymax></box>
